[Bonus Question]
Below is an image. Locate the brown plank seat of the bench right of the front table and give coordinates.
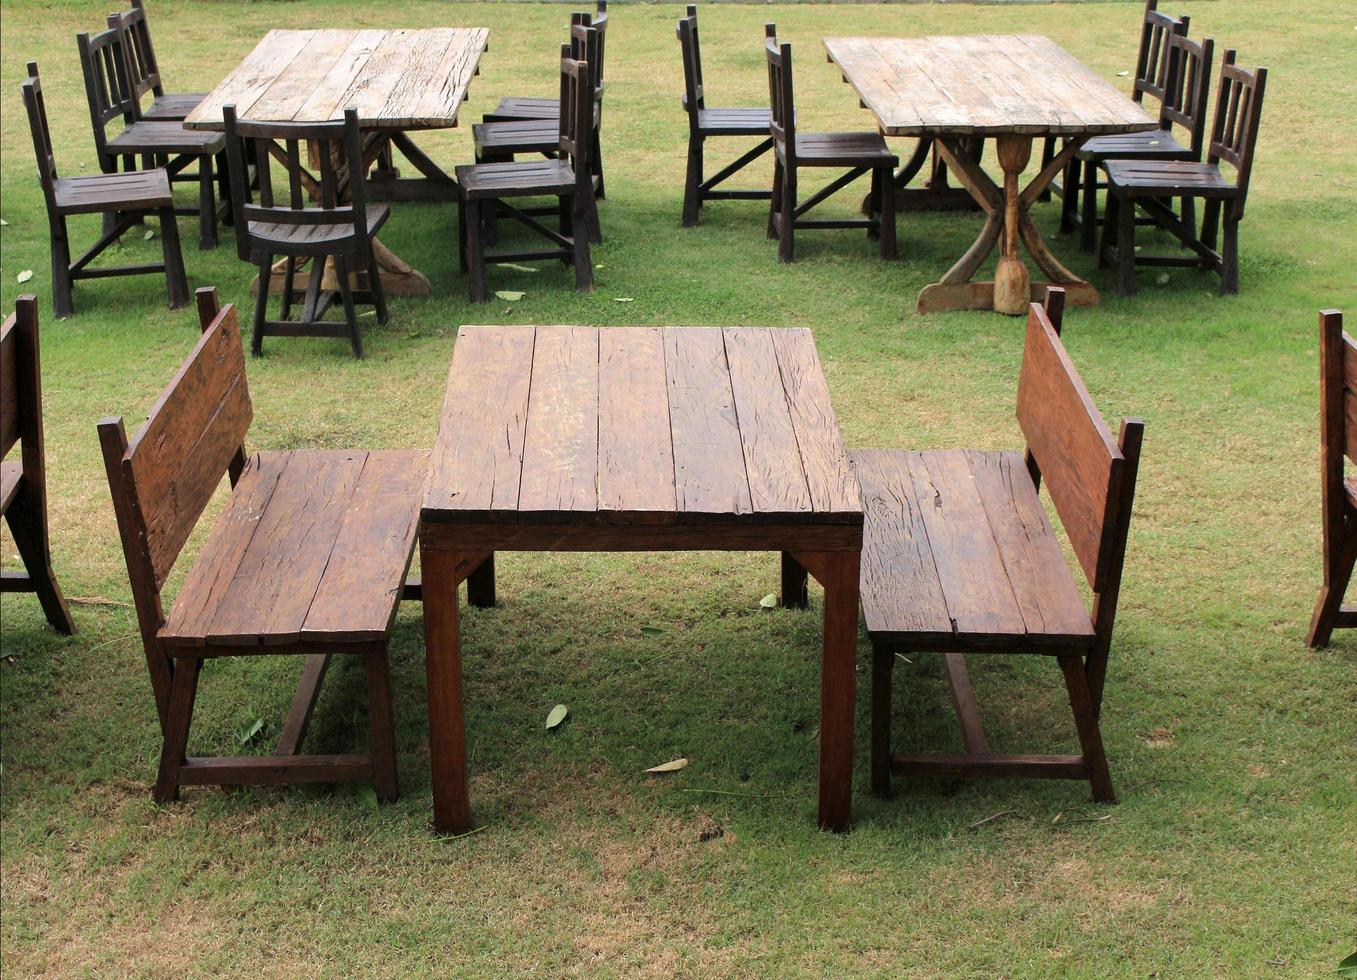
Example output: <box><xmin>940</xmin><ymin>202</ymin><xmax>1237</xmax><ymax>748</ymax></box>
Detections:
<box><xmin>849</xmin><ymin>449</ymin><xmax>1094</xmax><ymax>652</ymax></box>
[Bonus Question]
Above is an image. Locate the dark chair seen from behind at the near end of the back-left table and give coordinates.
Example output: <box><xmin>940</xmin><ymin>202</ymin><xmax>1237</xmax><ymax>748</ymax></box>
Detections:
<box><xmin>223</xmin><ymin>106</ymin><xmax>391</xmax><ymax>357</ymax></box>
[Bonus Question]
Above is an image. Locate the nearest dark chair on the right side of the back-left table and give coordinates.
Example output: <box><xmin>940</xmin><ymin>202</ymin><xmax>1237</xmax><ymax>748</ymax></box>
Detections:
<box><xmin>456</xmin><ymin>44</ymin><xmax>598</xmax><ymax>303</ymax></box>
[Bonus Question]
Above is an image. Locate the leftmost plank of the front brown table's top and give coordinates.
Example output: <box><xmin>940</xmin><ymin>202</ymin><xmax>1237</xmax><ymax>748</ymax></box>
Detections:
<box><xmin>423</xmin><ymin>326</ymin><xmax>536</xmax><ymax>521</ymax></box>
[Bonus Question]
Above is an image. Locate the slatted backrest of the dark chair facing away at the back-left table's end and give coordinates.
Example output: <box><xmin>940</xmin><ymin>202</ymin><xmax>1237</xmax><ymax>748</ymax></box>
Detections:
<box><xmin>221</xmin><ymin>105</ymin><xmax>369</xmax><ymax>267</ymax></box>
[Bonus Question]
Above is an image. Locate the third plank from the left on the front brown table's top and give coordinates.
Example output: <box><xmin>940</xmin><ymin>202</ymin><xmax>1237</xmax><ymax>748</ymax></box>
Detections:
<box><xmin>598</xmin><ymin>327</ymin><xmax>676</xmax><ymax>521</ymax></box>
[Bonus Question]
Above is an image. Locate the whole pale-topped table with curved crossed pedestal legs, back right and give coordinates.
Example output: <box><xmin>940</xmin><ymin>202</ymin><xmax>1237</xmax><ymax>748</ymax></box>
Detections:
<box><xmin>825</xmin><ymin>34</ymin><xmax>1158</xmax><ymax>314</ymax></box>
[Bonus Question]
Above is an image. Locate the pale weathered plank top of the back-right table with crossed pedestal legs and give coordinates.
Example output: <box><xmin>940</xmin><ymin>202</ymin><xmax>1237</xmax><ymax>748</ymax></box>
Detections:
<box><xmin>825</xmin><ymin>34</ymin><xmax>1158</xmax><ymax>136</ymax></box>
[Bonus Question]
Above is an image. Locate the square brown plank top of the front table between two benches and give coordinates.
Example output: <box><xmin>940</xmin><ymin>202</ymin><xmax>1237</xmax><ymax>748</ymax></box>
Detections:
<box><xmin>422</xmin><ymin>326</ymin><xmax>863</xmax><ymax>531</ymax></box>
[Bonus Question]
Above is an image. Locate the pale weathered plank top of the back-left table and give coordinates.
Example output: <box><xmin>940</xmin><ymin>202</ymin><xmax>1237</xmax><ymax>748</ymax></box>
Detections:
<box><xmin>185</xmin><ymin>27</ymin><xmax>490</xmax><ymax>129</ymax></box>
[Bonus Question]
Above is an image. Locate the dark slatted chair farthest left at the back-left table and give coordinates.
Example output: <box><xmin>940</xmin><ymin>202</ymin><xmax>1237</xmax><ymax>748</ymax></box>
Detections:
<box><xmin>22</xmin><ymin>61</ymin><xmax>189</xmax><ymax>318</ymax></box>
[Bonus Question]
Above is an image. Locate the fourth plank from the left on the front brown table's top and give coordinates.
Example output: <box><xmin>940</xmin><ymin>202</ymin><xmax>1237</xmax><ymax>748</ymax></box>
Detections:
<box><xmin>665</xmin><ymin>327</ymin><xmax>753</xmax><ymax>520</ymax></box>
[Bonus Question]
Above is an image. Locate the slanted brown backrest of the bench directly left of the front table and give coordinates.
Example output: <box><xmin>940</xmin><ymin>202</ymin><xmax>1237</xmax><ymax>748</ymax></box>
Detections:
<box><xmin>99</xmin><ymin>290</ymin><xmax>254</xmax><ymax>583</ymax></box>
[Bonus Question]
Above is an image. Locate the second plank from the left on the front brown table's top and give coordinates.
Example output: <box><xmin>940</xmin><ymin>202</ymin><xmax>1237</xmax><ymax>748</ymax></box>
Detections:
<box><xmin>518</xmin><ymin>327</ymin><xmax>598</xmax><ymax>520</ymax></box>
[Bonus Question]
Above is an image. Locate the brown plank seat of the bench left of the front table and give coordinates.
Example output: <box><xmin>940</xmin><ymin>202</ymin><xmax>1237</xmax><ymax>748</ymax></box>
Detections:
<box><xmin>159</xmin><ymin>449</ymin><xmax>429</xmax><ymax>646</ymax></box>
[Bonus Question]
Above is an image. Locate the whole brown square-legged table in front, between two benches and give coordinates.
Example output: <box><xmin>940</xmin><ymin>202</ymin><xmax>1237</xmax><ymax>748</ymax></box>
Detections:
<box><xmin>419</xmin><ymin>327</ymin><xmax>863</xmax><ymax>833</ymax></box>
